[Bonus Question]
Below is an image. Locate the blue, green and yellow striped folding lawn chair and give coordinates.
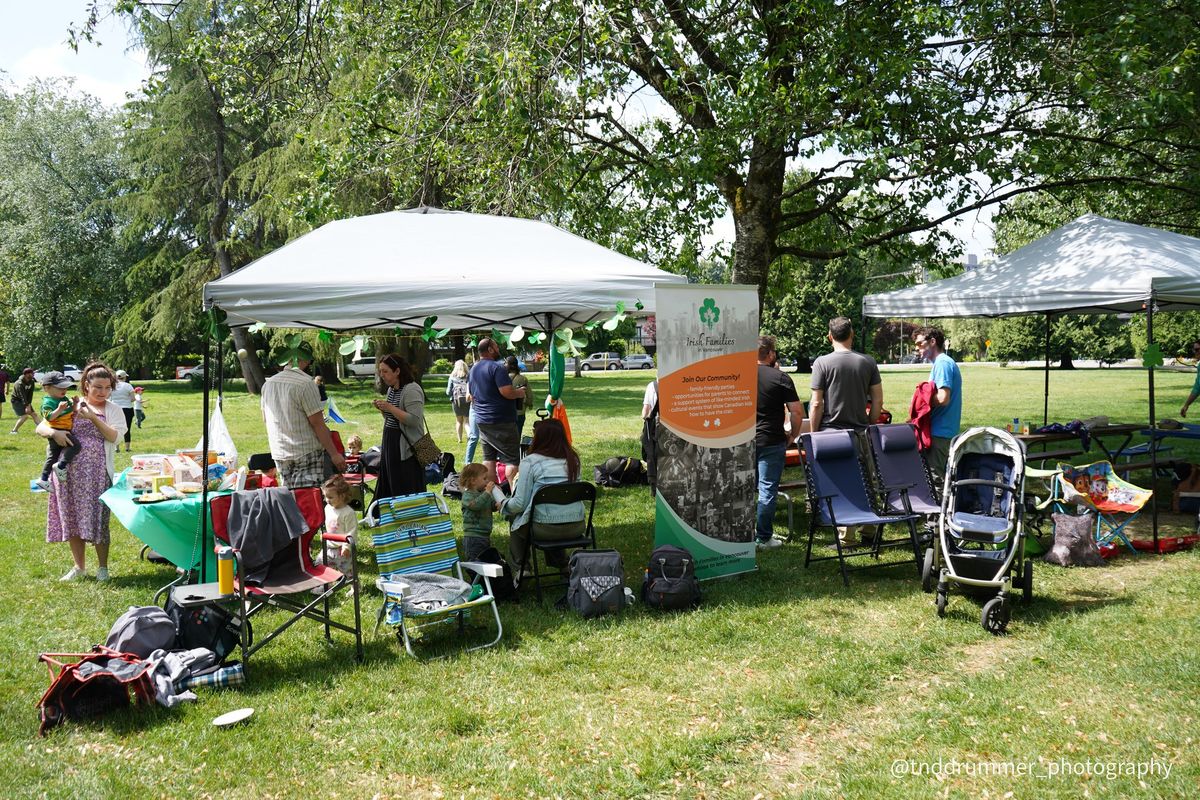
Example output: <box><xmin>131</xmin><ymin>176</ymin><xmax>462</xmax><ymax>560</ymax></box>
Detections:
<box><xmin>362</xmin><ymin>492</ymin><xmax>504</xmax><ymax>658</ymax></box>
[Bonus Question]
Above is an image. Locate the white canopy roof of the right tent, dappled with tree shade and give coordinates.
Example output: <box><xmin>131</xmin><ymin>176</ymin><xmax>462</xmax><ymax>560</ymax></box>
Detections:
<box><xmin>863</xmin><ymin>219</ymin><xmax>1200</xmax><ymax>318</ymax></box>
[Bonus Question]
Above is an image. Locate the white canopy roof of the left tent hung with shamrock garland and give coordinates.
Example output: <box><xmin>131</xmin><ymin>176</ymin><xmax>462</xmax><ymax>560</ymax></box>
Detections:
<box><xmin>204</xmin><ymin>209</ymin><xmax>686</xmax><ymax>331</ymax></box>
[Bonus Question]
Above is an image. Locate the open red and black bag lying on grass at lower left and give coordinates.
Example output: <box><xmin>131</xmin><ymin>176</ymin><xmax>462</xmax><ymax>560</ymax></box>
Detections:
<box><xmin>37</xmin><ymin>644</ymin><xmax>154</xmax><ymax>736</ymax></box>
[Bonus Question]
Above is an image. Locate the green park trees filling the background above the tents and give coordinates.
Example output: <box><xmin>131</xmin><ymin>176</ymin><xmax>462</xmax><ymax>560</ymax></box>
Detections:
<box><xmin>7</xmin><ymin>0</ymin><xmax>1200</xmax><ymax>381</ymax></box>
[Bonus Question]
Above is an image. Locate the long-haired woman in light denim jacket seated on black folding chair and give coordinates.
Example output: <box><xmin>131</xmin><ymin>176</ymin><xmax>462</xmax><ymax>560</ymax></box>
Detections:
<box><xmin>504</xmin><ymin>420</ymin><xmax>587</xmax><ymax>569</ymax></box>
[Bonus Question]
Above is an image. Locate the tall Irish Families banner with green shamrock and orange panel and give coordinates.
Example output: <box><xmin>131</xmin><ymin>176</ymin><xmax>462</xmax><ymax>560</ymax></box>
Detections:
<box><xmin>654</xmin><ymin>283</ymin><xmax>758</xmax><ymax>579</ymax></box>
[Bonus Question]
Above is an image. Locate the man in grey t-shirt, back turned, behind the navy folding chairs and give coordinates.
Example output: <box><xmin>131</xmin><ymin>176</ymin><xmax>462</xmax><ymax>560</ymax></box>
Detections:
<box><xmin>809</xmin><ymin>317</ymin><xmax>883</xmax><ymax>547</ymax></box>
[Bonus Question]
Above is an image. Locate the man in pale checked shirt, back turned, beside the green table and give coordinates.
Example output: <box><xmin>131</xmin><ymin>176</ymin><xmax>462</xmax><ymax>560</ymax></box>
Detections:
<box><xmin>262</xmin><ymin>342</ymin><xmax>346</xmax><ymax>489</ymax></box>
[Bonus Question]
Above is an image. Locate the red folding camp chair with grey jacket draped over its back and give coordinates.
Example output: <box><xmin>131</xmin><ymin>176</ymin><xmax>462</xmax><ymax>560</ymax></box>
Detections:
<box><xmin>172</xmin><ymin>488</ymin><xmax>362</xmax><ymax>663</ymax></box>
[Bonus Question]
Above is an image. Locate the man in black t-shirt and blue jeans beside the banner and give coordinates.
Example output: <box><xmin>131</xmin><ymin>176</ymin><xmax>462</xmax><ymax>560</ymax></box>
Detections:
<box><xmin>754</xmin><ymin>336</ymin><xmax>804</xmax><ymax>549</ymax></box>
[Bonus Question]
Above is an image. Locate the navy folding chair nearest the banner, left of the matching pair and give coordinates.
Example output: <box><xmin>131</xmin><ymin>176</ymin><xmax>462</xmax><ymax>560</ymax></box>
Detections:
<box><xmin>800</xmin><ymin>431</ymin><xmax>920</xmax><ymax>587</ymax></box>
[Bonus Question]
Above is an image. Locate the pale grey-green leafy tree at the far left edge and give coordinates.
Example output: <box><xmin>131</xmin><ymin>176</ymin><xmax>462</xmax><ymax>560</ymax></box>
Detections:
<box><xmin>0</xmin><ymin>82</ymin><xmax>133</xmax><ymax>367</ymax></box>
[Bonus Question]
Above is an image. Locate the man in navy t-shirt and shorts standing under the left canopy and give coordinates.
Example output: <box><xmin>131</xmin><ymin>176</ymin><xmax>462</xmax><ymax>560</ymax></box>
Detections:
<box><xmin>467</xmin><ymin>338</ymin><xmax>528</xmax><ymax>486</ymax></box>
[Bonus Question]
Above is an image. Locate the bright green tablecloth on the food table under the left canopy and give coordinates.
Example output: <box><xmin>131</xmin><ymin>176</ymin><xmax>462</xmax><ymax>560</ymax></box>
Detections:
<box><xmin>100</xmin><ymin>473</ymin><xmax>217</xmax><ymax>581</ymax></box>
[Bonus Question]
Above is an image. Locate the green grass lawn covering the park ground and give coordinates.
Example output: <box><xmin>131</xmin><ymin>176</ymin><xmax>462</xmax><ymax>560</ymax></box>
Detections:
<box><xmin>0</xmin><ymin>365</ymin><xmax>1200</xmax><ymax>799</ymax></box>
